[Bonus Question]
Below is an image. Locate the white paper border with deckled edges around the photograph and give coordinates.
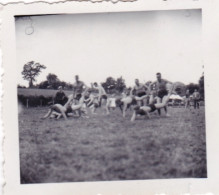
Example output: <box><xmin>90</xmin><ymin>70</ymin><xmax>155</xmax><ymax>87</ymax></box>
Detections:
<box><xmin>1</xmin><ymin>0</ymin><xmax>219</xmax><ymax>195</ymax></box>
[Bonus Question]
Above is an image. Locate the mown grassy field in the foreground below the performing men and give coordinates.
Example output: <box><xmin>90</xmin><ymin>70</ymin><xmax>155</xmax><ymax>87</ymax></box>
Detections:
<box><xmin>19</xmin><ymin>107</ymin><xmax>207</xmax><ymax>183</ymax></box>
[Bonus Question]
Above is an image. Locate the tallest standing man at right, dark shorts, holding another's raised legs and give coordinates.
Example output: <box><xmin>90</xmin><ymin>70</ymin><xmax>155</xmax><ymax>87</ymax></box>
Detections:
<box><xmin>153</xmin><ymin>72</ymin><xmax>172</xmax><ymax>116</ymax></box>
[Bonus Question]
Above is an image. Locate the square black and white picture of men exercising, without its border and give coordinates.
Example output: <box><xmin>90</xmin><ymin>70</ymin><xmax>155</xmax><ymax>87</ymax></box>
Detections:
<box><xmin>12</xmin><ymin>9</ymin><xmax>208</xmax><ymax>184</ymax></box>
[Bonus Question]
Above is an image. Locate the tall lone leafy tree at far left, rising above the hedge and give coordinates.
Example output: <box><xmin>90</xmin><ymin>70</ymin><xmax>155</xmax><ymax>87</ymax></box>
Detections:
<box><xmin>21</xmin><ymin>61</ymin><xmax>46</xmax><ymax>88</ymax></box>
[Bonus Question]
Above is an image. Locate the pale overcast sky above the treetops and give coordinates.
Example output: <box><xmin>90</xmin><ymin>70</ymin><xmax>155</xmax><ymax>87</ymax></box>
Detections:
<box><xmin>16</xmin><ymin>10</ymin><xmax>203</xmax><ymax>86</ymax></box>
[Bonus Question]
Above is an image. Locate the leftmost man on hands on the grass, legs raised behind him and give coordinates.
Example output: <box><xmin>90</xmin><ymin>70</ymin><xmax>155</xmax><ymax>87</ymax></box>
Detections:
<box><xmin>42</xmin><ymin>88</ymin><xmax>88</xmax><ymax>119</ymax></box>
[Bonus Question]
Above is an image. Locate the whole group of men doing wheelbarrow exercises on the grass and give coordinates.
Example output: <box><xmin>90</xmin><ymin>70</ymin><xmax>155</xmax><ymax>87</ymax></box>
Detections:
<box><xmin>43</xmin><ymin>73</ymin><xmax>178</xmax><ymax>121</ymax></box>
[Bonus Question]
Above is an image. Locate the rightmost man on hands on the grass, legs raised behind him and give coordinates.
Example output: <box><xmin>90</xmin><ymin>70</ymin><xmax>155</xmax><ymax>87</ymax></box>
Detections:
<box><xmin>131</xmin><ymin>85</ymin><xmax>174</xmax><ymax>121</ymax></box>
